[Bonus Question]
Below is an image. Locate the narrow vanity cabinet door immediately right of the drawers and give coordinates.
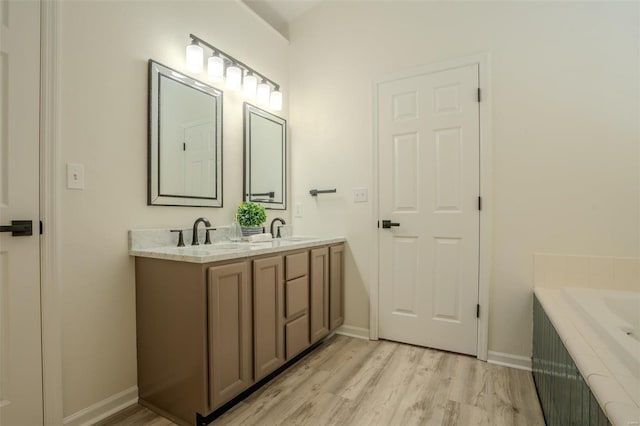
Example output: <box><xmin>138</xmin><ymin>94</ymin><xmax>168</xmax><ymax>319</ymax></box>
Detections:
<box><xmin>309</xmin><ymin>247</ymin><xmax>329</xmax><ymax>343</ymax></box>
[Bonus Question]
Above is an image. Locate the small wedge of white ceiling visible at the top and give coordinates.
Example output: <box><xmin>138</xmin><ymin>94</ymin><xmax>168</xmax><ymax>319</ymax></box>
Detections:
<box><xmin>242</xmin><ymin>0</ymin><xmax>322</xmax><ymax>39</ymax></box>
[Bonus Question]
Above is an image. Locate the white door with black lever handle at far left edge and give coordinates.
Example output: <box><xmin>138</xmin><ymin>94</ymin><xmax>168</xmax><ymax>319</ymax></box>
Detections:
<box><xmin>0</xmin><ymin>0</ymin><xmax>43</xmax><ymax>426</ymax></box>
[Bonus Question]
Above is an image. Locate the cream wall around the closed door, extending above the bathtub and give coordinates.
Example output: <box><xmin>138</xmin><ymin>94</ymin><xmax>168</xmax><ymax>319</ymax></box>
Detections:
<box><xmin>289</xmin><ymin>1</ymin><xmax>640</xmax><ymax>356</ymax></box>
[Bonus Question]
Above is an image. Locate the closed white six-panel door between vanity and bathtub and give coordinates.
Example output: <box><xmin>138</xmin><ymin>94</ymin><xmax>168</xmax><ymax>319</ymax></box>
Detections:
<box><xmin>377</xmin><ymin>64</ymin><xmax>480</xmax><ymax>355</ymax></box>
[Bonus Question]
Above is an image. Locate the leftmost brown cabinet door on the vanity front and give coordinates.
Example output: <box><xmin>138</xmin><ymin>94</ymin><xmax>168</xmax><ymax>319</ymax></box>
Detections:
<box><xmin>208</xmin><ymin>262</ymin><xmax>253</xmax><ymax>410</ymax></box>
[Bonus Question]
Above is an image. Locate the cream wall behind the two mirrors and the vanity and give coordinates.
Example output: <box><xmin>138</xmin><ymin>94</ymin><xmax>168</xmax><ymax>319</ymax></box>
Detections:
<box><xmin>58</xmin><ymin>1</ymin><xmax>289</xmax><ymax>416</ymax></box>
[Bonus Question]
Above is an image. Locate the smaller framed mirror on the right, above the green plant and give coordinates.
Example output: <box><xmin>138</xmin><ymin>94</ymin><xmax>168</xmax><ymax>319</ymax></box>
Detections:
<box><xmin>244</xmin><ymin>102</ymin><xmax>287</xmax><ymax>210</ymax></box>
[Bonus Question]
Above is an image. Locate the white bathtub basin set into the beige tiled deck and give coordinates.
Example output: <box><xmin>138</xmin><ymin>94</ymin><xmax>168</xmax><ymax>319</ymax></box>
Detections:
<box><xmin>562</xmin><ymin>288</ymin><xmax>640</xmax><ymax>379</ymax></box>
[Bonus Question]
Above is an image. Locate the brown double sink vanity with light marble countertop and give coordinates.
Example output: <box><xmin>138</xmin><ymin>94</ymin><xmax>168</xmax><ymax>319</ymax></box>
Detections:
<box><xmin>129</xmin><ymin>230</ymin><xmax>344</xmax><ymax>425</ymax></box>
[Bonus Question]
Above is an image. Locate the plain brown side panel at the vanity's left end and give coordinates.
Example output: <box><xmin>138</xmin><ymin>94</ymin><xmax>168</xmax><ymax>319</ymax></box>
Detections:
<box><xmin>136</xmin><ymin>257</ymin><xmax>211</xmax><ymax>422</ymax></box>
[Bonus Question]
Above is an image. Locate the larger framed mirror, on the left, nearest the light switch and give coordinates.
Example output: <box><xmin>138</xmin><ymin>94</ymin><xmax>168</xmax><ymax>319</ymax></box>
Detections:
<box><xmin>148</xmin><ymin>60</ymin><xmax>222</xmax><ymax>207</ymax></box>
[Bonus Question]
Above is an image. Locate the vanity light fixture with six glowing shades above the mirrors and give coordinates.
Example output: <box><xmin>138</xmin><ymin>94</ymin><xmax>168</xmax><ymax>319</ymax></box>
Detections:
<box><xmin>187</xmin><ymin>34</ymin><xmax>282</xmax><ymax>111</ymax></box>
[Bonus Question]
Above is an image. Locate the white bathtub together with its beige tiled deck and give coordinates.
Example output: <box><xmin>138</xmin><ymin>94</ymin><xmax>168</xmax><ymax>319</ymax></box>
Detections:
<box><xmin>534</xmin><ymin>287</ymin><xmax>640</xmax><ymax>426</ymax></box>
